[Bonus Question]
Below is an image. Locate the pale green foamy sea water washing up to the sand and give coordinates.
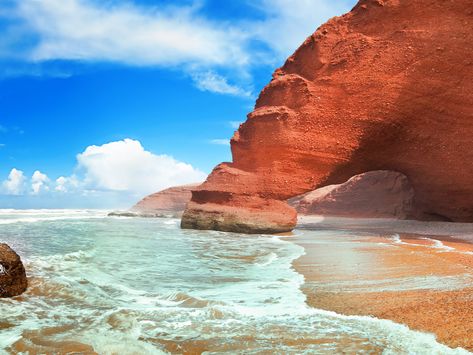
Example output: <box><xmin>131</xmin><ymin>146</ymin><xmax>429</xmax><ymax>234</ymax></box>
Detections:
<box><xmin>0</xmin><ymin>210</ymin><xmax>466</xmax><ymax>354</ymax></box>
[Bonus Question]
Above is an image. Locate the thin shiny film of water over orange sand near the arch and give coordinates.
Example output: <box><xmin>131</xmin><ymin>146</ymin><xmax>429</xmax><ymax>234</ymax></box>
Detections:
<box><xmin>292</xmin><ymin>229</ymin><xmax>473</xmax><ymax>293</ymax></box>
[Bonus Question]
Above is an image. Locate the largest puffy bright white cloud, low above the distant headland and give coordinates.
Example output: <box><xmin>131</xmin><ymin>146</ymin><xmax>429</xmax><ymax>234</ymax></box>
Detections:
<box><xmin>77</xmin><ymin>139</ymin><xmax>206</xmax><ymax>194</ymax></box>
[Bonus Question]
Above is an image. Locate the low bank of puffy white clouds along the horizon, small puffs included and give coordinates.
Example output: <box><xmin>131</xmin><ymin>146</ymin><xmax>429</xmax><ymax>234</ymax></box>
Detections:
<box><xmin>1</xmin><ymin>139</ymin><xmax>207</xmax><ymax>206</ymax></box>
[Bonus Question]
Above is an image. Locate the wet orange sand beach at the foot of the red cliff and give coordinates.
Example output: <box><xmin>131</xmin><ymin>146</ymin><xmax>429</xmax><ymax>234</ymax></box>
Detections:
<box><xmin>291</xmin><ymin>217</ymin><xmax>473</xmax><ymax>351</ymax></box>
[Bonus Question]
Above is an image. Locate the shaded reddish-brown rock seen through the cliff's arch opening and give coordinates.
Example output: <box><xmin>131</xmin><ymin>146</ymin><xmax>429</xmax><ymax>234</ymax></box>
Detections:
<box><xmin>288</xmin><ymin>170</ymin><xmax>414</xmax><ymax>219</ymax></box>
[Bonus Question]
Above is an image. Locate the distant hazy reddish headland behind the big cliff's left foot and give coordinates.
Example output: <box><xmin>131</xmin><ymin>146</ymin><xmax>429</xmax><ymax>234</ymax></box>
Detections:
<box><xmin>131</xmin><ymin>184</ymin><xmax>200</xmax><ymax>217</ymax></box>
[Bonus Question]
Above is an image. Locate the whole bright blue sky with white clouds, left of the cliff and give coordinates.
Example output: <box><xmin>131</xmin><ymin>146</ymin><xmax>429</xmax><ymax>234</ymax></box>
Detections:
<box><xmin>0</xmin><ymin>0</ymin><xmax>355</xmax><ymax>208</ymax></box>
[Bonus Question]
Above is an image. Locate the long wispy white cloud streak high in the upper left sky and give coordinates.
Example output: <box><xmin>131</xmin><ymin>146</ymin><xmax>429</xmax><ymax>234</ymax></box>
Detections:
<box><xmin>17</xmin><ymin>0</ymin><xmax>248</xmax><ymax>66</ymax></box>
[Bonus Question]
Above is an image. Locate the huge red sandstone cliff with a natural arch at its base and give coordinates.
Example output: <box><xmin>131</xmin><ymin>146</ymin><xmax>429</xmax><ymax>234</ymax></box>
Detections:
<box><xmin>182</xmin><ymin>0</ymin><xmax>473</xmax><ymax>233</ymax></box>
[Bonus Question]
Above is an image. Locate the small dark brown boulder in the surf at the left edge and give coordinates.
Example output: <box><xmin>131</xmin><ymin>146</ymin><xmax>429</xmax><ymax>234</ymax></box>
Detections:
<box><xmin>0</xmin><ymin>243</ymin><xmax>28</xmax><ymax>298</ymax></box>
